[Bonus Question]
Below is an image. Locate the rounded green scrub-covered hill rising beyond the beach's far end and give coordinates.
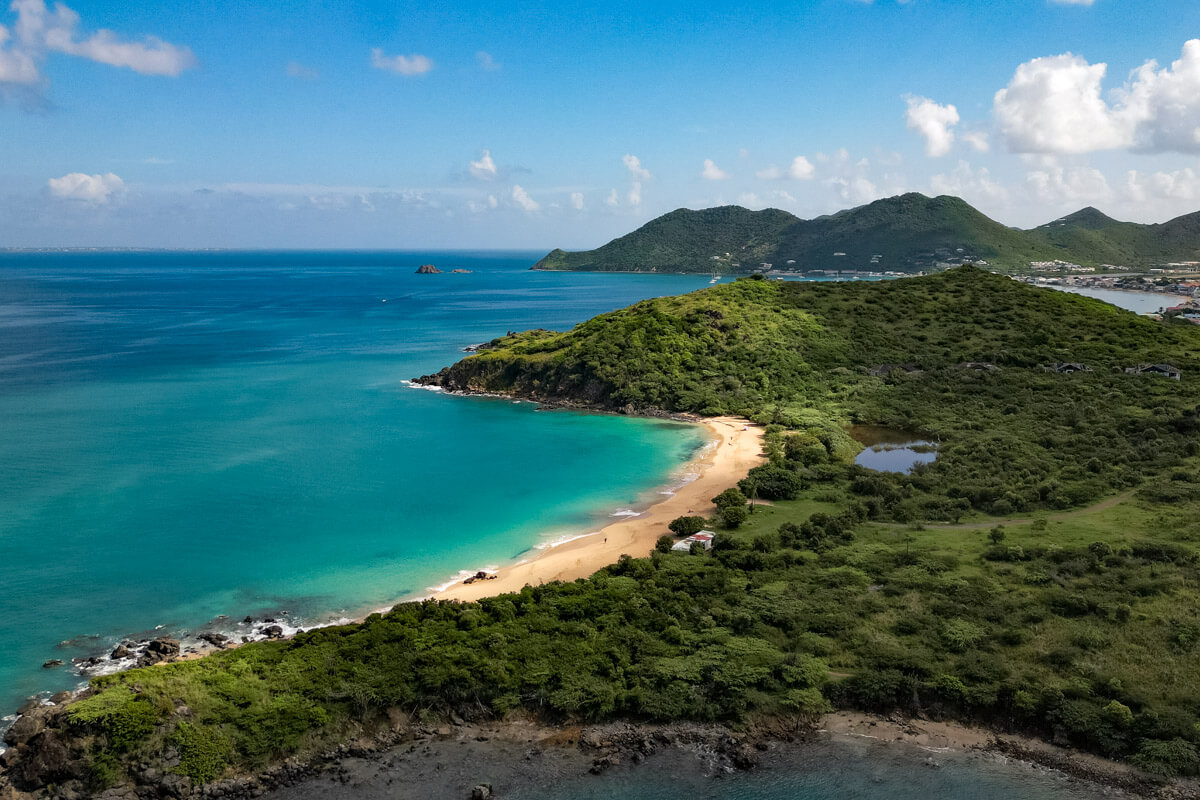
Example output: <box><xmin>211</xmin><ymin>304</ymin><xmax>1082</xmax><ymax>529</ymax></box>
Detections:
<box><xmin>421</xmin><ymin>267</ymin><xmax>1200</xmax><ymax>415</ymax></box>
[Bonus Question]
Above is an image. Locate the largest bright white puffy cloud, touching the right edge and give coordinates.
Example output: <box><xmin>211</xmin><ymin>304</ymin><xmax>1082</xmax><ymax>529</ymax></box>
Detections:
<box><xmin>992</xmin><ymin>40</ymin><xmax>1200</xmax><ymax>154</ymax></box>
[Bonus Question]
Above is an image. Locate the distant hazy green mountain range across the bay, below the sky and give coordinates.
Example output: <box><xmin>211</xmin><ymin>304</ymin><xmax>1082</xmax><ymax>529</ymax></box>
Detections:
<box><xmin>533</xmin><ymin>193</ymin><xmax>1200</xmax><ymax>273</ymax></box>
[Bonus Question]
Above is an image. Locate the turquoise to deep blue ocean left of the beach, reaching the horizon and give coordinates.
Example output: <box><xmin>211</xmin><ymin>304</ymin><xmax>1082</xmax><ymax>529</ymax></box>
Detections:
<box><xmin>0</xmin><ymin>252</ymin><xmax>707</xmax><ymax>716</ymax></box>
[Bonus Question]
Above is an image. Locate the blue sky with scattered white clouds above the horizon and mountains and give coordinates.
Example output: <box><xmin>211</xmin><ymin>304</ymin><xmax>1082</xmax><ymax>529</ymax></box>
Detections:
<box><xmin>0</xmin><ymin>0</ymin><xmax>1200</xmax><ymax>248</ymax></box>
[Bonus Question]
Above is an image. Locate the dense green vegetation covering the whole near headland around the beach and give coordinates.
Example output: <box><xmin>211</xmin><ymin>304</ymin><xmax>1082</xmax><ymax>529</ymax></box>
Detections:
<box><xmin>9</xmin><ymin>267</ymin><xmax>1200</xmax><ymax>786</ymax></box>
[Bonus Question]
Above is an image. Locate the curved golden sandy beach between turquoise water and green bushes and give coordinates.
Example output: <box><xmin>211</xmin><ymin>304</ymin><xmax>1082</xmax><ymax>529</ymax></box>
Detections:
<box><xmin>432</xmin><ymin>416</ymin><xmax>766</xmax><ymax>601</ymax></box>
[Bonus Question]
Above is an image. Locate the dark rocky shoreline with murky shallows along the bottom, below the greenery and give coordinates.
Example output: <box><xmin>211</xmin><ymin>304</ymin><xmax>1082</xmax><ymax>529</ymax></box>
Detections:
<box><xmin>7</xmin><ymin>698</ymin><xmax>1200</xmax><ymax>800</ymax></box>
